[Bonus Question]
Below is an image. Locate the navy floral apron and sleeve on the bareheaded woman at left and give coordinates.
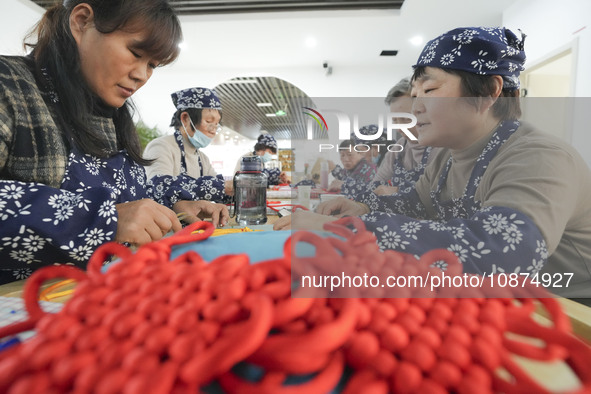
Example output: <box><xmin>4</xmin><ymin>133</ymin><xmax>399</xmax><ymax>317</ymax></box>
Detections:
<box><xmin>0</xmin><ymin>149</ymin><xmax>149</xmax><ymax>283</ymax></box>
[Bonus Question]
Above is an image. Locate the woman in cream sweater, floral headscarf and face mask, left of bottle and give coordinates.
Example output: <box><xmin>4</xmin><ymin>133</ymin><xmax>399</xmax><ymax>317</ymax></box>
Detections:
<box><xmin>144</xmin><ymin>88</ymin><xmax>232</xmax><ymax>204</ymax></box>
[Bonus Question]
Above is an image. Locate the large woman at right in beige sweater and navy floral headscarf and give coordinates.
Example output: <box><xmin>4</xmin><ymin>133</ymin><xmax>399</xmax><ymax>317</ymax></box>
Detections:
<box><xmin>275</xmin><ymin>27</ymin><xmax>591</xmax><ymax>298</ymax></box>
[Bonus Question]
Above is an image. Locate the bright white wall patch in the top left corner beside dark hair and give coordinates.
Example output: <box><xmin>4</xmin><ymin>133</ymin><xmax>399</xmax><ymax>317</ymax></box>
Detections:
<box><xmin>0</xmin><ymin>0</ymin><xmax>44</xmax><ymax>55</ymax></box>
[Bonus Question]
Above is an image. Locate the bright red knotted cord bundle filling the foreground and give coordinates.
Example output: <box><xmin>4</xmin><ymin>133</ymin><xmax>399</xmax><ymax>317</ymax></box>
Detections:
<box><xmin>0</xmin><ymin>218</ymin><xmax>591</xmax><ymax>394</ymax></box>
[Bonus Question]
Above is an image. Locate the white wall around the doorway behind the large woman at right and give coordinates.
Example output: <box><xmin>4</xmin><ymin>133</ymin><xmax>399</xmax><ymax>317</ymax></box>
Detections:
<box><xmin>503</xmin><ymin>0</ymin><xmax>591</xmax><ymax>166</ymax></box>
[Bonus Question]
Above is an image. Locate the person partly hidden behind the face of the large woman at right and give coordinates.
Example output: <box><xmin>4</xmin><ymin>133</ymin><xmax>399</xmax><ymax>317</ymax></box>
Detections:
<box><xmin>374</xmin><ymin>77</ymin><xmax>443</xmax><ymax>195</ymax></box>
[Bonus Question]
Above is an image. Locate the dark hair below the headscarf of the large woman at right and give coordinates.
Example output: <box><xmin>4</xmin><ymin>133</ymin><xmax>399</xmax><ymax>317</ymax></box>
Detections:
<box><xmin>412</xmin><ymin>67</ymin><xmax>521</xmax><ymax>120</ymax></box>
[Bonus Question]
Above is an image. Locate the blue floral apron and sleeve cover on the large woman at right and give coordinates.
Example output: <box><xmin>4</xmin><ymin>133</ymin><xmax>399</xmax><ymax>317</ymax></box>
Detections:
<box><xmin>362</xmin><ymin>121</ymin><xmax>548</xmax><ymax>274</ymax></box>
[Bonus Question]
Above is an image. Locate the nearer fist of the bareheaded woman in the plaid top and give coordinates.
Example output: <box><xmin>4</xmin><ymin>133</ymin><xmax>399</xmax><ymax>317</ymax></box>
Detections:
<box><xmin>115</xmin><ymin>199</ymin><xmax>182</xmax><ymax>245</ymax></box>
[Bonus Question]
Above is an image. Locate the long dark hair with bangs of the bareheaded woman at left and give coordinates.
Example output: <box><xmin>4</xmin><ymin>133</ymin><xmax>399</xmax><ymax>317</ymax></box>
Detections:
<box><xmin>25</xmin><ymin>0</ymin><xmax>182</xmax><ymax>165</ymax></box>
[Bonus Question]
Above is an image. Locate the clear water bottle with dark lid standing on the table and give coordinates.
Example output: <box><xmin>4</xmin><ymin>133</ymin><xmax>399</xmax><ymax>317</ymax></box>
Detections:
<box><xmin>234</xmin><ymin>156</ymin><xmax>267</xmax><ymax>226</ymax></box>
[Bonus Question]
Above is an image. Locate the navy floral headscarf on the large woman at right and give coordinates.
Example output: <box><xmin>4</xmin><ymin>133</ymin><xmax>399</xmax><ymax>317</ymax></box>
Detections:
<box><xmin>413</xmin><ymin>27</ymin><xmax>525</xmax><ymax>90</ymax></box>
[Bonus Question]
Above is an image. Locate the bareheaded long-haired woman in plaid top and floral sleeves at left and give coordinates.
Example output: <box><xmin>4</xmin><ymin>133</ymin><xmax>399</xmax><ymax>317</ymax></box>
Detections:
<box><xmin>0</xmin><ymin>0</ymin><xmax>227</xmax><ymax>283</ymax></box>
